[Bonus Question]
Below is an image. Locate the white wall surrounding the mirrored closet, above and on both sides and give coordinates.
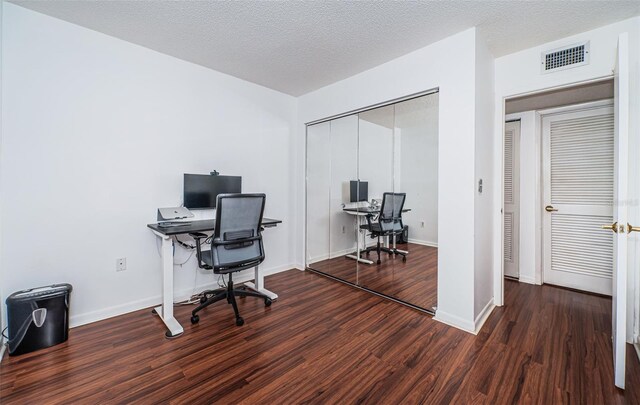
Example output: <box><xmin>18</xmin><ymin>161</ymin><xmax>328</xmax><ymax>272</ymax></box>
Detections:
<box><xmin>297</xmin><ymin>29</ymin><xmax>476</xmax><ymax>330</ymax></box>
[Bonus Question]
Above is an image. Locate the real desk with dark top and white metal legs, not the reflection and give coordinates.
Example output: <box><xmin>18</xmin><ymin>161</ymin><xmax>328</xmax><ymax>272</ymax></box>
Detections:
<box><xmin>147</xmin><ymin>218</ymin><xmax>282</xmax><ymax>337</ymax></box>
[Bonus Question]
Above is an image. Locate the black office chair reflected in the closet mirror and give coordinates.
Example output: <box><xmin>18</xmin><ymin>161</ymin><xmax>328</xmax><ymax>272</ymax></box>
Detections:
<box><xmin>360</xmin><ymin>193</ymin><xmax>408</xmax><ymax>264</ymax></box>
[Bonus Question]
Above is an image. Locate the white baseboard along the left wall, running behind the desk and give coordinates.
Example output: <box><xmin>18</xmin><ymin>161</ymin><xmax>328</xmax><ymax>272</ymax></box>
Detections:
<box><xmin>69</xmin><ymin>264</ymin><xmax>297</xmax><ymax>328</ymax></box>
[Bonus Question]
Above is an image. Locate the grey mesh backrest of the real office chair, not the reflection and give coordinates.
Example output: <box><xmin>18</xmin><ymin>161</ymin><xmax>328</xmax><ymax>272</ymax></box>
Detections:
<box><xmin>211</xmin><ymin>194</ymin><xmax>266</xmax><ymax>273</ymax></box>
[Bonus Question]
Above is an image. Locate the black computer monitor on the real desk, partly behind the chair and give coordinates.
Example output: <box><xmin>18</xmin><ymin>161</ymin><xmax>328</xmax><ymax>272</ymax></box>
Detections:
<box><xmin>184</xmin><ymin>173</ymin><xmax>242</xmax><ymax>209</ymax></box>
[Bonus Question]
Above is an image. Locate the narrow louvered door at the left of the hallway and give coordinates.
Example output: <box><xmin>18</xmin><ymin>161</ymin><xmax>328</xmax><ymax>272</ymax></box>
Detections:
<box><xmin>504</xmin><ymin>121</ymin><xmax>520</xmax><ymax>277</ymax></box>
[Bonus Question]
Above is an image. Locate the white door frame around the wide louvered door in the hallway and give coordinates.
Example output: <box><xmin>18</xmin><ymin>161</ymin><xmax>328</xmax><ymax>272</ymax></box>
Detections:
<box><xmin>536</xmin><ymin>99</ymin><xmax>615</xmax><ymax>292</ymax></box>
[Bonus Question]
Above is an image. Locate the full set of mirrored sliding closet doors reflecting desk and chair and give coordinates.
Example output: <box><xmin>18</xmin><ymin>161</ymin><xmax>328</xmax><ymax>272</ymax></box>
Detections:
<box><xmin>306</xmin><ymin>92</ymin><xmax>438</xmax><ymax>311</ymax></box>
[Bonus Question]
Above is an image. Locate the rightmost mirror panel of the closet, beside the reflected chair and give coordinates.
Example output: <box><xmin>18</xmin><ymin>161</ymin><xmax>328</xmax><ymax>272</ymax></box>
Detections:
<box><xmin>394</xmin><ymin>93</ymin><xmax>438</xmax><ymax>309</ymax></box>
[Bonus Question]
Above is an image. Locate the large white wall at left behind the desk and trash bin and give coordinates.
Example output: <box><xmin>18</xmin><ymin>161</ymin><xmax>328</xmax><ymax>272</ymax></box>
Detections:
<box><xmin>0</xmin><ymin>4</ymin><xmax>298</xmax><ymax>324</ymax></box>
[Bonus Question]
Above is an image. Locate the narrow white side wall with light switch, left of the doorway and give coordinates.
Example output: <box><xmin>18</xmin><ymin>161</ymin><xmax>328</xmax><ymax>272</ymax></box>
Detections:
<box><xmin>473</xmin><ymin>31</ymin><xmax>495</xmax><ymax>324</ymax></box>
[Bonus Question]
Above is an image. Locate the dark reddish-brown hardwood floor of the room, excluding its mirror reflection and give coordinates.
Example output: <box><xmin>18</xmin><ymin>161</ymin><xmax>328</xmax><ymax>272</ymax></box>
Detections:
<box><xmin>0</xmin><ymin>270</ymin><xmax>640</xmax><ymax>404</ymax></box>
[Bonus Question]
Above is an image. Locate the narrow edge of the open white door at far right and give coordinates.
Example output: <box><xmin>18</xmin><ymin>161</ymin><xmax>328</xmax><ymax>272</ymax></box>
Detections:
<box><xmin>611</xmin><ymin>33</ymin><xmax>631</xmax><ymax>388</ymax></box>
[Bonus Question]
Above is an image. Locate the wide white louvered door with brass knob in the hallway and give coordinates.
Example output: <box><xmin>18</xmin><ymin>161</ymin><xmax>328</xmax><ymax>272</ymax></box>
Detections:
<box><xmin>542</xmin><ymin>103</ymin><xmax>614</xmax><ymax>295</ymax></box>
